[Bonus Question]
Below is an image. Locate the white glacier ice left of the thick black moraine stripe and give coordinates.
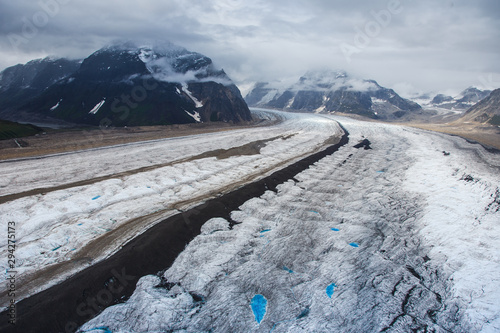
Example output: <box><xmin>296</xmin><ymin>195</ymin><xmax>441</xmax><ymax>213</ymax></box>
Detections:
<box><xmin>0</xmin><ymin>111</ymin><xmax>341</xmax><ymax>299</ymax></box>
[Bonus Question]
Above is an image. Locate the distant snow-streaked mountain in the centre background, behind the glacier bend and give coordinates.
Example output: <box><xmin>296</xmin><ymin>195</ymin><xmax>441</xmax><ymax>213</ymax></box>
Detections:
<box><xmin>245</xmin><ymin>70</ymin><xmax>421</xmax><ymax>119</ymax></box>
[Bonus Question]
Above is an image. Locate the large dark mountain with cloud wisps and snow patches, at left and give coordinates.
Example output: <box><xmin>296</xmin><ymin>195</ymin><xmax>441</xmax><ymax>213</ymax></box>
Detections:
<box><xmin>0</xmin><ymin>42</ymin><xmax>251</xmax><ymax>126</ymax></box>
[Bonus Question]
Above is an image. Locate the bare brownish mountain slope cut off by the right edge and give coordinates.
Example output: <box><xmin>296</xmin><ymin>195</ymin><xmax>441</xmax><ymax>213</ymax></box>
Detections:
<box><xmin>459</xmin><ymin>89</ymin><xmax>500</xmax><ymax>126</ymax></box>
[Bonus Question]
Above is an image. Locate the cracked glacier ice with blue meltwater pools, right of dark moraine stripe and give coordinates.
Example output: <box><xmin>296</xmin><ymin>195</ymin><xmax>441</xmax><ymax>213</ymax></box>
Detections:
<box><xmin>79</xmin><ymin>115</ymin><xmax>500</xmax><ymax>333</ymax></box>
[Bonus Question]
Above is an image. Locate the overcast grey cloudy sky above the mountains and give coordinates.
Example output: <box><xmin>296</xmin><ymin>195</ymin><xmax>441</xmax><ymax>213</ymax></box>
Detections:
<box><xmin>0</xmin><ymin>0</ymin><xmax>500</xmax><ymax>96</ymax></box>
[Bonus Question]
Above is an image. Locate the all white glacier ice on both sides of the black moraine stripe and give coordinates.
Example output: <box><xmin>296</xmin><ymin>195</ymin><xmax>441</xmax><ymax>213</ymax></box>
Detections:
<box><xmin>0</xmin><ymin>110</ymin><xmax>500</xmax><ymax>332</ymax></box>
